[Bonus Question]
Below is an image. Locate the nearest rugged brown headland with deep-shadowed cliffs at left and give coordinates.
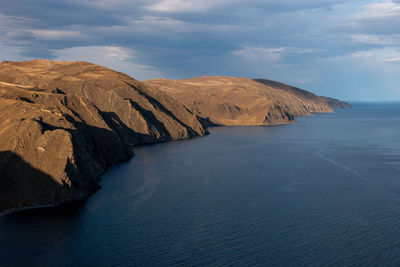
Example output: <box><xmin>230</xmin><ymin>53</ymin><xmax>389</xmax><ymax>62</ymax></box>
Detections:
<box><xmin>0</xmin><ymin>60</ymin><xmax>207</xmax><ymax>215</ymax></box>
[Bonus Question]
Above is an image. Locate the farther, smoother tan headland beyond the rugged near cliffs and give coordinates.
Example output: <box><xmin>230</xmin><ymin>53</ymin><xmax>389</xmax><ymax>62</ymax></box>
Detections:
<box><xmin>146</xmin><ymin>77</ymin><xmax>332</xmax><ymax>125</ymax></box>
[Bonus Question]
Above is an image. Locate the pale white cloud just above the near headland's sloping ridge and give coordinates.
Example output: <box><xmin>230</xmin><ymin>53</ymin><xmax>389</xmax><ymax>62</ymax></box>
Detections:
<box><xmin>53</xmin><ymin>46</ymin><xmax>162</xmax><ymax>80</ymax></box>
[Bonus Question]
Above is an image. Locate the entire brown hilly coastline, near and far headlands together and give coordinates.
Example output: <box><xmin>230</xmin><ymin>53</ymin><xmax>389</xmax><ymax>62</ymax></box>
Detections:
<box><xmin>0</xmin><ymin>59</ymin><xmax>350</xmax><ymax>214</ymax></box>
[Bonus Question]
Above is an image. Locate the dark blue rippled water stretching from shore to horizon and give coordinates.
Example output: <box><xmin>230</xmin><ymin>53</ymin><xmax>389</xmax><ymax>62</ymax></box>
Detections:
<box><xmin>0</xmin><ymin>103</ymin><xmax>400</xmax><ymax>266</ymax></box>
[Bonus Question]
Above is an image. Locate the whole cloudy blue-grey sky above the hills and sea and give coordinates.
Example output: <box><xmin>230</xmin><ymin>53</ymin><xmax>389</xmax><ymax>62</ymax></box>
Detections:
<box><xmin>0</xmin><ymin>0</ymin><xmax>400</xmax><ymax>101</ymax></box>
